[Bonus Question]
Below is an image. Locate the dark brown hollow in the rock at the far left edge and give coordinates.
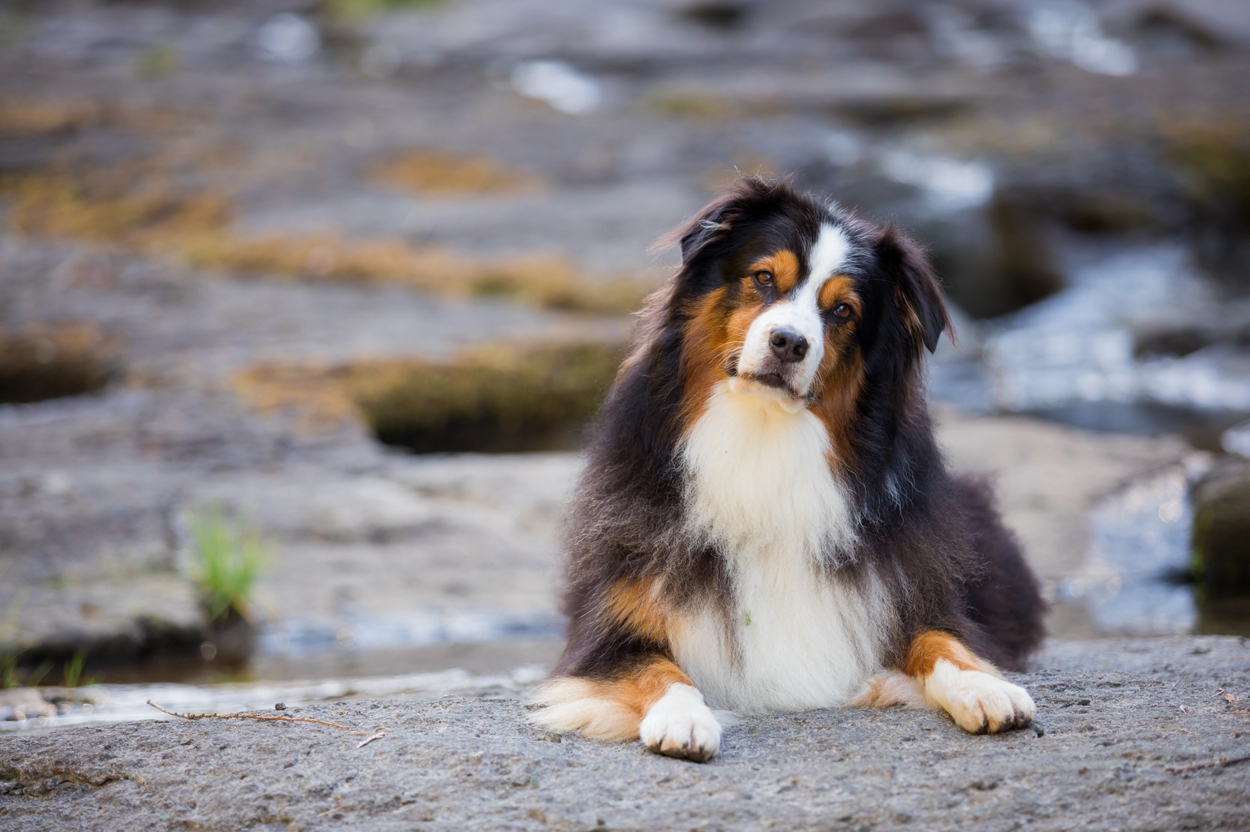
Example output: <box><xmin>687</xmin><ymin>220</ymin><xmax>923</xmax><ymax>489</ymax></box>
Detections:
<box><xmin>0</xmin><ymin>324</ymin><xmax>118</xmax><ymax>405</ymax></box>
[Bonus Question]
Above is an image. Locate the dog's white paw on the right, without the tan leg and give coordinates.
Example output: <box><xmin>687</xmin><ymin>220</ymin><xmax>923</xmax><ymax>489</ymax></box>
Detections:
<box><xmin>925</xmin><ymin>660</ymin><xmax>1036</xmax><ymax>733</ymax></box>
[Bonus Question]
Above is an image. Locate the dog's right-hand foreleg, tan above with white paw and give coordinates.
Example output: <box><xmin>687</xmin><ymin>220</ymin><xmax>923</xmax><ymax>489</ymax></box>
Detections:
<box><xmin>903</xmin><ymin>630</ymin><xmax>1035</xmax><ymax>733</ymax></box>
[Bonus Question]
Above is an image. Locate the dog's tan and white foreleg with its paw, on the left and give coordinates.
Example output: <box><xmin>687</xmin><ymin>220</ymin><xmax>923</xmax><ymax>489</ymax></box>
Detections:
<box><xmin>531</xmin><ymin>657</ymin><xmax>720</xmax><ymax>762</ymax></box>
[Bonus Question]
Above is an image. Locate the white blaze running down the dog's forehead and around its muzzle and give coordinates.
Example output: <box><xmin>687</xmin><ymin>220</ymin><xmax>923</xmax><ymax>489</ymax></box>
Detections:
<box><xmin>731</xmin><ymin>222</ymin><xmax>851</xmax><ymax>399</ymax></box>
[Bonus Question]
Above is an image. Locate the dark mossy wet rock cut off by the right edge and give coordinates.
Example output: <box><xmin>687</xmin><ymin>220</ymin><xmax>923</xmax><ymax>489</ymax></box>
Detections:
<box><xmin>1191</xmin><ymin>460</ymin><xmax>1250</xmax><ymax>598</ymax></box>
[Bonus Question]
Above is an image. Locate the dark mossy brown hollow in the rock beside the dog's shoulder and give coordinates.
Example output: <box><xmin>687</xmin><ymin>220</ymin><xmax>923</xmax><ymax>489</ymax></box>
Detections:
<box><xmin>235</xmin><ymin>342</ymin><xmax>625</xmax><ymax>453</ymax></box>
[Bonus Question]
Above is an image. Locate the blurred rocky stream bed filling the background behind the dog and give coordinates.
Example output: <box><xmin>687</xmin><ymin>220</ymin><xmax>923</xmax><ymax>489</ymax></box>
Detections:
<box><xmin>0</xmin><ymin>0</ymin><xmax>1250</xmax><ymax>727</ymax></box>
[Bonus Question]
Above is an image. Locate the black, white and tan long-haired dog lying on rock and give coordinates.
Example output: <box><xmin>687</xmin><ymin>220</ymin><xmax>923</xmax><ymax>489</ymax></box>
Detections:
<box><xmin>533</xmin><ymin>179</ymin><xmax>1045</xmax><ymax>762</ymax></box>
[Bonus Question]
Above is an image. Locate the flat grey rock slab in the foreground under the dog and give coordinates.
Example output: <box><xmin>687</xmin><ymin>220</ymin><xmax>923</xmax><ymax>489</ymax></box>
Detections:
<box><xmin>0</xmin><ymin>637</ymin><xmax>1250</xmax><ymax>831</ymax></box>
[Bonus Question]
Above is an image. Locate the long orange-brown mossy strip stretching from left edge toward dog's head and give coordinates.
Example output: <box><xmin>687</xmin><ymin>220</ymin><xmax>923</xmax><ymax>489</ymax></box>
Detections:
<box><xmin>7</xmin><ymin>165</ymin><xmax>650</xmax><ymax>314</ymax></box>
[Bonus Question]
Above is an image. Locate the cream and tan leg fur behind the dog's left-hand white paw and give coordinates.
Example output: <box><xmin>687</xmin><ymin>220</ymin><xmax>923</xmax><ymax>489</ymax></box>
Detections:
<box><xmin>530</xmin><ymin>658</ymin><xmax>694</xmax><ymax>742</ymax></box>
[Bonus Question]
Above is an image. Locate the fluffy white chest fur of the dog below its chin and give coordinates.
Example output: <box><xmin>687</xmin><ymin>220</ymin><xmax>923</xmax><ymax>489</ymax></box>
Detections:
<box><xmin>670</xmin><ymin>386</ymin><xmax>889</xmax><ymax>711</ymax></box>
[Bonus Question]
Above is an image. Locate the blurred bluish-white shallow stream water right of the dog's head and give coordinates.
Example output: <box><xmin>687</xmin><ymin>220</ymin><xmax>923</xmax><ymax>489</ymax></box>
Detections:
<box><xmin>930</xmin><ymin>245</ymin><xmax>1250</xmax><ymax>451</ymax></box>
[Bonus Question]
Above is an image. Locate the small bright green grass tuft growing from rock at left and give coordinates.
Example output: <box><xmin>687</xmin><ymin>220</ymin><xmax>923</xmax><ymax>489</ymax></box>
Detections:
<box><xmin>188</xmin><ymin>510</ymin><xmax>269</xmax><ymax>621</ymax></box>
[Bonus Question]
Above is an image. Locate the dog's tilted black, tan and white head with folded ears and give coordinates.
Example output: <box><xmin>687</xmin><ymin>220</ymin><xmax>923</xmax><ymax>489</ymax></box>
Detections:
<box><xmin>665</xmin><ymin>179</ymin><xmax>950</xmax><ymax>428</ymax></box>
